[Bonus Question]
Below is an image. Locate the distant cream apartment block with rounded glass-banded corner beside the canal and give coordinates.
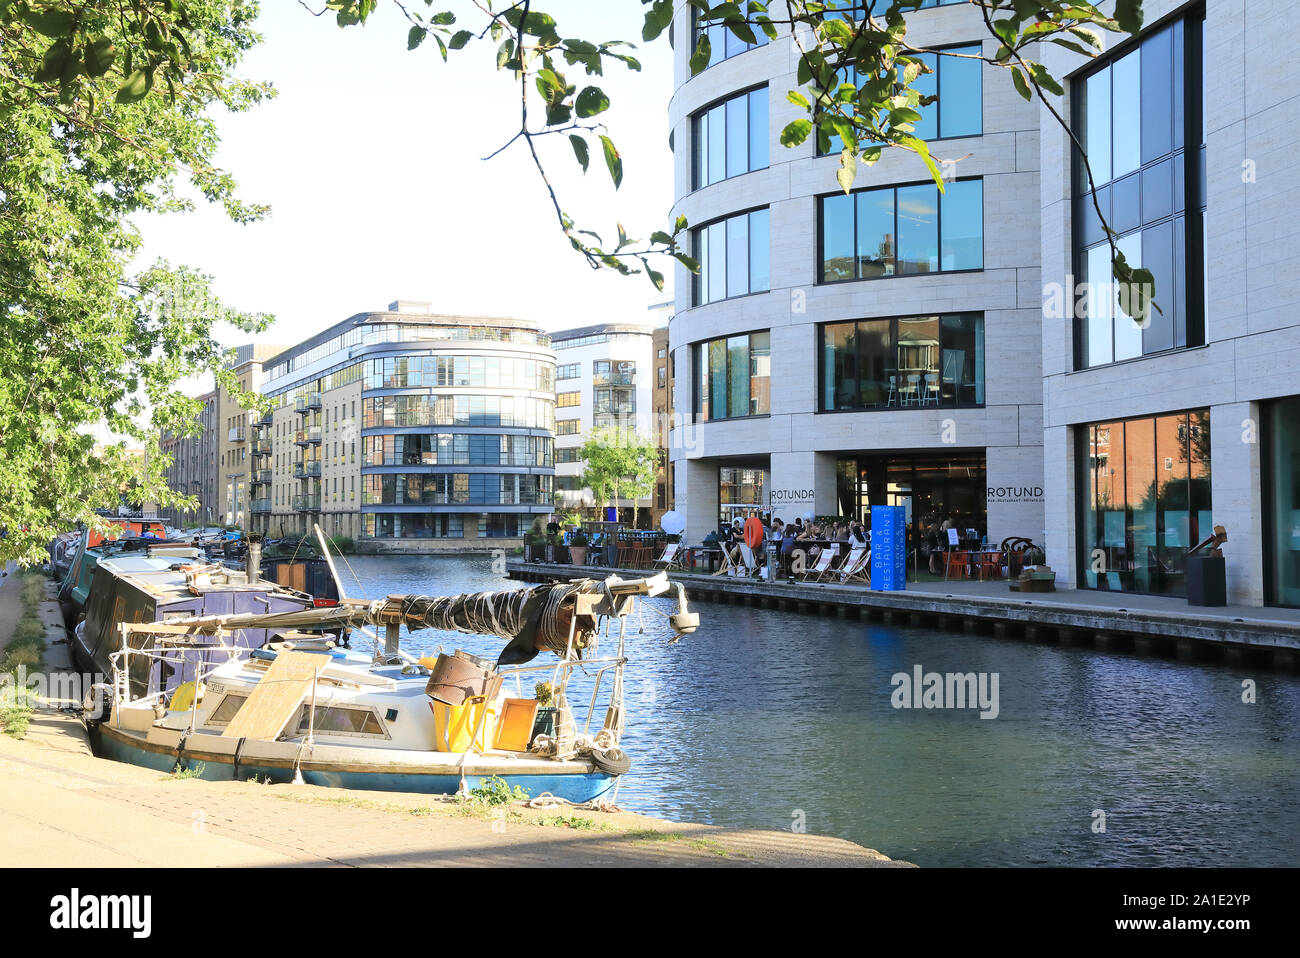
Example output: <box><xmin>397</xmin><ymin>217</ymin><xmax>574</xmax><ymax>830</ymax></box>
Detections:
<box><xmin>256</xmin><ymin>300</ymin><xmax>555</xmax><ymax>551</ymax></box>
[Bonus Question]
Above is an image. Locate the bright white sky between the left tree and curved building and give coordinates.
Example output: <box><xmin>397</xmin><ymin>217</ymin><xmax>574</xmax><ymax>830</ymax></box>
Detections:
<box><xmin>138</xmin><ymin>0</ymin><xmax>672</xmax><ymax>371</ymax></box>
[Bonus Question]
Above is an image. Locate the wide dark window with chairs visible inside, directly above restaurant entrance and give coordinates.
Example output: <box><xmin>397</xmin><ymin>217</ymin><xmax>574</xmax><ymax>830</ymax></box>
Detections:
<box><xmin>820</xmin><ymin>313</ymin><xmax>984</xmax><ymax>412</ymax></box>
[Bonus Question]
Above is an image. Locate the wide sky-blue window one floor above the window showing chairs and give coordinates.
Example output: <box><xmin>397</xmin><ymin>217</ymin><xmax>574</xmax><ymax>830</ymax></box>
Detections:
<box><xmin>820</xmin><ymin>179</ymin><xmax>984</xmax><ymax>283</ymax></box>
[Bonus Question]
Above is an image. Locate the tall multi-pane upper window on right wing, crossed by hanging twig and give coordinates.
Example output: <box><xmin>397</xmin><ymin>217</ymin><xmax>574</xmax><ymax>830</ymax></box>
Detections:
<box><xmin>1074</xmin><ymin>18</ymin><xmax>1205</xmax><ymax>368</ymax></box>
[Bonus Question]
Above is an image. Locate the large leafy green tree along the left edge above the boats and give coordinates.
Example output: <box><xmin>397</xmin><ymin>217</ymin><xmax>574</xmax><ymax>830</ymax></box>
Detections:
<box><xmin>0</xmin><ymin>0</ymin><xmax>270</xmax><ymax>562</ymax></box>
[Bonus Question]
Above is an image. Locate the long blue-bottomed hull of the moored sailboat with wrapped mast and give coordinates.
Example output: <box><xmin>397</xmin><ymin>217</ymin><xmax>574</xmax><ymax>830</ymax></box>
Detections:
<box><xmin>88</xmin><ymin>723</ymin><xmax>616</xmax><ymax>805</ymax></box>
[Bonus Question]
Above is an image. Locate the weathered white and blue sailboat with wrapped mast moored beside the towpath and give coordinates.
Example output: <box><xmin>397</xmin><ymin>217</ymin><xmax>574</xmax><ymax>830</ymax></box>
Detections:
<box><xmin>87</xmin><ymin>573</ymin><xmax>699</xmax><ymax>805</ymax></box>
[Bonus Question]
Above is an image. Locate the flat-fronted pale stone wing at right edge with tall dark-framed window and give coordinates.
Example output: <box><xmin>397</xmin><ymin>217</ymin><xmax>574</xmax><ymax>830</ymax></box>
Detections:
<box><xmin>1039</xmin><ymin>0</ymin><xmax>1300</xmax><ymax>606</ymax></box>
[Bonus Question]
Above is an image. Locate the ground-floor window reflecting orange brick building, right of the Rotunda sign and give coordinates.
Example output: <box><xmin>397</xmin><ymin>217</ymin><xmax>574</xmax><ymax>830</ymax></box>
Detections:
<box><xmin>1079</xmin><ymin>409</ymin><xmax>1214</xmax><ymax>595</ymax></box>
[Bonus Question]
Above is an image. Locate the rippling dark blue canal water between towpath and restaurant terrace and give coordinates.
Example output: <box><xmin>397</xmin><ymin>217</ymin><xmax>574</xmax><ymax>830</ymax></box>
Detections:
<box><xmin>341</xmin><ymin>556</ymin><xmax>1300</xmax><ymax>866</ymax></box>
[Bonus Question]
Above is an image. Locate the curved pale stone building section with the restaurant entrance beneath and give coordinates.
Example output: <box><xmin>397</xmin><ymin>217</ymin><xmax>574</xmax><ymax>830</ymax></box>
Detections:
<box><xmin>670</xmin><ymin>3</ymin><xmax>1044</xmax><ymax>541</ymax></box>
